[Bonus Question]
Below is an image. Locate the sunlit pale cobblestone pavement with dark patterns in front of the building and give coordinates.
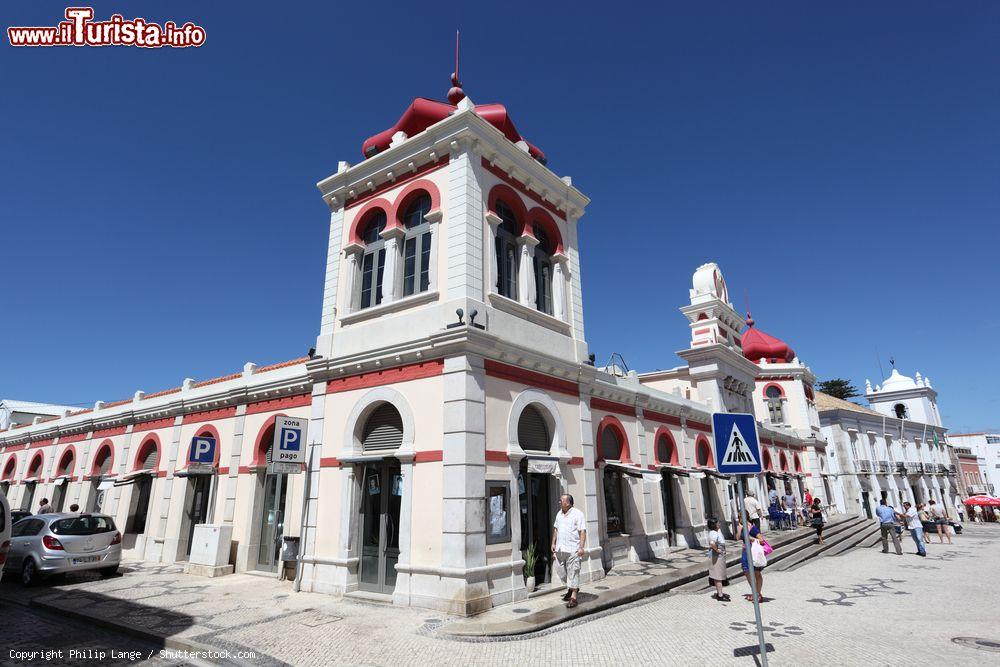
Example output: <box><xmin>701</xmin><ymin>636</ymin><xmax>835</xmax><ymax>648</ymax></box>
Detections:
<box><xmin>0</xmin><ymin>525</ymin><xmax>1000</xmax><ymax>666</ymax></box>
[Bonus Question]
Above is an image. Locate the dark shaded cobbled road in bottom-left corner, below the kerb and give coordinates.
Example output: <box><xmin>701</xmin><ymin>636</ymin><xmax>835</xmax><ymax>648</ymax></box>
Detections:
<box><xmin>0</xmin><ymin>603</ymin><xmax>189</xmax><ymax>667</ymax></box>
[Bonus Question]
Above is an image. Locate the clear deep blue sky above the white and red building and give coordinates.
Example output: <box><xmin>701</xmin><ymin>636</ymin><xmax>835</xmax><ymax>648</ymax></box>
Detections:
<box><xmin>0</xmin><ymin>0</ymin><xmax>1000</xmax><ymax>430</ymax></box>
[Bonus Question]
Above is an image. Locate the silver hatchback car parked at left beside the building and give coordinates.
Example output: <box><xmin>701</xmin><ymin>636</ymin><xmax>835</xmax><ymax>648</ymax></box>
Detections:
<box><xmin>4</xmin><ymin>513</ymin><xmax>122</xmax><ymax>586</ymax></box>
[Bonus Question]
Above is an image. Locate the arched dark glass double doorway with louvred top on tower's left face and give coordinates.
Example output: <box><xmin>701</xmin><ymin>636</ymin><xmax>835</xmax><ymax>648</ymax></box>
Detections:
<box><xmin>358</xmin><ymin>403</ymin><xmax>403</xmax><ymax>594</ymax></box>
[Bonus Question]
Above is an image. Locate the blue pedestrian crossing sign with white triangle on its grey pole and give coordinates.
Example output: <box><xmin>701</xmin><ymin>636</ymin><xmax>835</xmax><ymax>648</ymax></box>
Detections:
<box><xmin>712</xmin><ymin>412</ymin><xmax>767</xmax><ymax>667</ymax></box>
